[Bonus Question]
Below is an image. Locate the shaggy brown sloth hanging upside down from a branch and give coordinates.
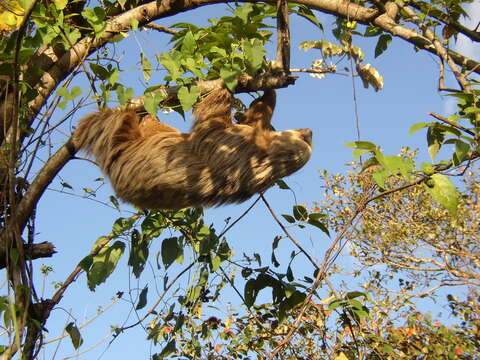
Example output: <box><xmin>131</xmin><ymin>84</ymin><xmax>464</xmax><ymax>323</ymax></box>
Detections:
<box><xmin>73</xmin><ymin>89</ymin><xmax>312</xmax><ymax>209</ymax></box>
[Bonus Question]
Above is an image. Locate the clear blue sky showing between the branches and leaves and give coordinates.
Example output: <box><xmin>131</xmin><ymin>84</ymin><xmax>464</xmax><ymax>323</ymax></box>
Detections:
<box><xmin>9</xmin><ymin>1</ymin><xmax>480</xmax><ymax>359</ymax></box>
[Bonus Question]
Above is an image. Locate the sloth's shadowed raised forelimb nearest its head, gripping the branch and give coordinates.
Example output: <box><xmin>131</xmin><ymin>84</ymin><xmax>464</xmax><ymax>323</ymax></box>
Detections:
<box><xmin>242</xmin><ymin>89</ymin><xmax>276</xmax><ymax>131</ymax></box>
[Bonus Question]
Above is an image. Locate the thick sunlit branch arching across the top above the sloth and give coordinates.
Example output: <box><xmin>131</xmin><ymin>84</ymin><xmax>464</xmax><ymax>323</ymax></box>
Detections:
<box><xmin>13</xmin><ymin>0</ymin><xmax>480</xmax><ymax>135</ymax></box>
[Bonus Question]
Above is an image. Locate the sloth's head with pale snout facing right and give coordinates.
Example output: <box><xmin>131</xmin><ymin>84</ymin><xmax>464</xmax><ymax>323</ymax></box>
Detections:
<box><xmin>268</xmin><ymin>129</ymin><xmax>312</xmax><ymax>177</ymax></box>
